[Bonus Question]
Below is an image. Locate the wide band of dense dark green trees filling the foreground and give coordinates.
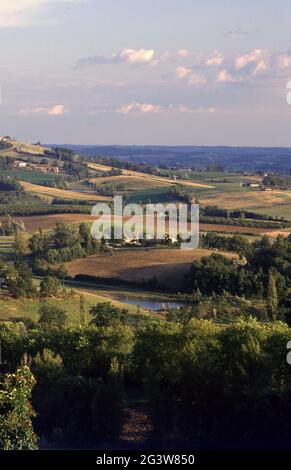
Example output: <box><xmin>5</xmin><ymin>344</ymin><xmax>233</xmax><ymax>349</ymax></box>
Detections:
<box><xmin>0</xmin><ymin>312</ymin><xmax>291</xmax><ymax>449</ymax></box>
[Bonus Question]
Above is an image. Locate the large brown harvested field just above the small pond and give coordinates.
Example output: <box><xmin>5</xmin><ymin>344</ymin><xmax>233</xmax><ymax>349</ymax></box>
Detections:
<box><xmin>66</xmin><ymin>249</ymin><xmax>237</xmax><ymax>289</ymax></box>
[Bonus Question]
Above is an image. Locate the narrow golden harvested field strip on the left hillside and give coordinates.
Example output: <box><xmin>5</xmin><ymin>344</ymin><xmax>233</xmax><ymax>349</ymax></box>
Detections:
<box><xmin>20</xmin><ymin>181</ymin><xmax>111</xmax><ymax>201</ymax></box>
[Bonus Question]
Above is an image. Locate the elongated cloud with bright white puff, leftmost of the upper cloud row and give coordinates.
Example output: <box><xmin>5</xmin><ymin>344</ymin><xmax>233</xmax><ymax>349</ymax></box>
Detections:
<box><xmin>77</xmin><ymin>49</ymin><xmax>156</xmax><ymax>65</ymax></box>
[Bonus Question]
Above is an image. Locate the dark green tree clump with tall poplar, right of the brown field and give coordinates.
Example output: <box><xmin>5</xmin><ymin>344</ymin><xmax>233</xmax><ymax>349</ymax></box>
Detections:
<box><xmin>185</xmin><ymin>234</ymin><xmax>291</xmax><ymax>322</ymax></box>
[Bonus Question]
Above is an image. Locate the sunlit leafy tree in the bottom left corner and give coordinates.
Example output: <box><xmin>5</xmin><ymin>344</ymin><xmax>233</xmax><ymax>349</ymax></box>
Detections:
<box><xmin>0</xmin><ymin>366</ymin><xmax>37</xmax><ymax>450</ymax></box>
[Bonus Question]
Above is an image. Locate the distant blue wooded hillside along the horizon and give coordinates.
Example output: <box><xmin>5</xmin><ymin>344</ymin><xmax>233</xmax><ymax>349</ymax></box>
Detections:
<box><xmin>48</xmin><ymin>145</ymin><xmax>291</xmax><ymax>172</ymax></box>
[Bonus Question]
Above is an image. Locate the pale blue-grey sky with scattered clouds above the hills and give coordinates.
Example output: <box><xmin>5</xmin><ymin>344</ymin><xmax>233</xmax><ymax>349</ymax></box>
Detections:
<box><xmin>0</xmin><ymin>0</ymin><xmax>291</xmax><ymax>147</ymax></box>
